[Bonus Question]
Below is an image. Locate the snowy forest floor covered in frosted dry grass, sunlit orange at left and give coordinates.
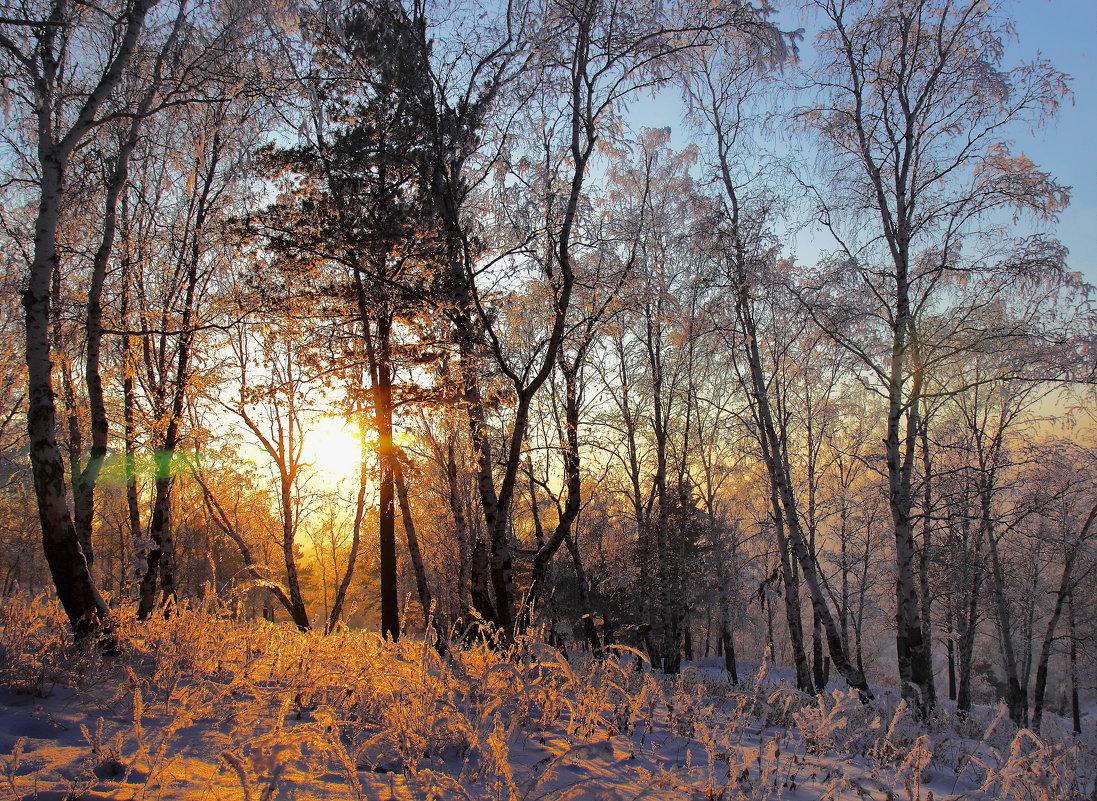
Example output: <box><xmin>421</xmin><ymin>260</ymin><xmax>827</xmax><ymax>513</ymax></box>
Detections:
<box><xmin>0</xmin><ymin>599</ymin><xmax>1097</xmax><ymax>801</ymax></box>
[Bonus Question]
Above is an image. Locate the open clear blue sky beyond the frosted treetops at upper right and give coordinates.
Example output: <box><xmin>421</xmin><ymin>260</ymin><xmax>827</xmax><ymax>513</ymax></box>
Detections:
<box><xmin>630</xmin><ymin>0</ymin><xmax>1097</xmax><ymax>284</ymax></box>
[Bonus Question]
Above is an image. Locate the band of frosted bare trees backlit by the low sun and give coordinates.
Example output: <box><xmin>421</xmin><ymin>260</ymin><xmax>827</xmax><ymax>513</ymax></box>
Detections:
<box><xmin>0</xmin><ymin>0</ymin><xmax>1097</xmax><ymax>727</ymax></box>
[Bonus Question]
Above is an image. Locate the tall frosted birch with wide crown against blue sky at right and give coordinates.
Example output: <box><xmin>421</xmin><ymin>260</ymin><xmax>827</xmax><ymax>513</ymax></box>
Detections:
<box><xmin>799</xmin><ymin>0</ymin><xmax>1067</xmax><ymax>713</ymax></box>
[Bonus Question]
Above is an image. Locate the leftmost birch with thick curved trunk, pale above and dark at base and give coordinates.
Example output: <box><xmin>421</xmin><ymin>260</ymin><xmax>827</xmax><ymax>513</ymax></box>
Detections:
<box><xmin>0</xmin><ymin>0</ymin><xmax>164</xmax><ymax>635</ymax></box>
